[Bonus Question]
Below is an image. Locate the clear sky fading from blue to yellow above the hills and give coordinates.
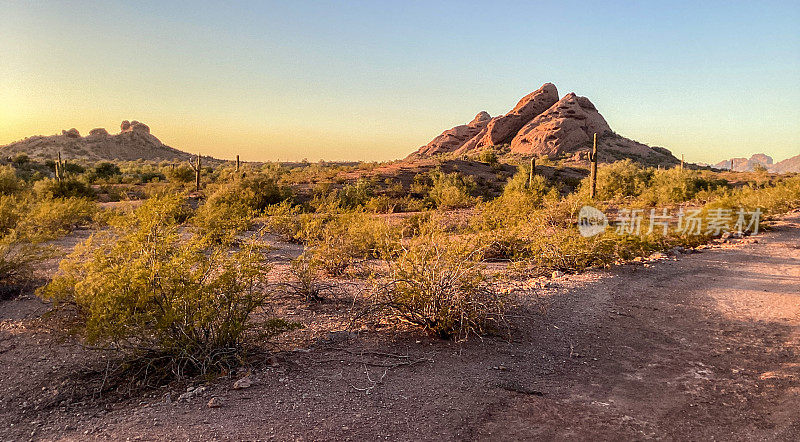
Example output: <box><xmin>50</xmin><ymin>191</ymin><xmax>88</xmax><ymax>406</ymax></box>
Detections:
<box><xmin>0</xmin><ymin>0</ymin><xmax>800</xmax><ymax>162</ymax></box>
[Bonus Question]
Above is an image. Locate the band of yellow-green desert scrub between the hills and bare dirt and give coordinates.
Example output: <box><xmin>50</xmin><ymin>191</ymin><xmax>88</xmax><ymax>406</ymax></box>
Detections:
<box><xmin>0</xmin><ymin>152</ymin><xmax>800</xmax><ymax>386</ymax></box>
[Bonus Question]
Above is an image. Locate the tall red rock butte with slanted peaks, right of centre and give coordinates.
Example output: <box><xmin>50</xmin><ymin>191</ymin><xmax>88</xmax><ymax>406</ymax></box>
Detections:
<box><xmin>410</xmin><ymin>83</ymin><xmax>680</xmax><ymax>166</ymax></box>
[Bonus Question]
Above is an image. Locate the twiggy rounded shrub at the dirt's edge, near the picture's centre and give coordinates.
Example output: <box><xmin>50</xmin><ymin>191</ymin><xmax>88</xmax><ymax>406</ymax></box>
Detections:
<box><xmin>375</xmin><ymin>230</ymin><xmax>507</xmax><ymax>339</ymax></box>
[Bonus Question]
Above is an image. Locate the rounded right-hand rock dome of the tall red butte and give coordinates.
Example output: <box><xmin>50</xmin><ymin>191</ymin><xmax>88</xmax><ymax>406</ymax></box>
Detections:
<box><xmin>511</xmin><ymin>93</ymin><xmax>611</xmax><ymax>155</ymax></box>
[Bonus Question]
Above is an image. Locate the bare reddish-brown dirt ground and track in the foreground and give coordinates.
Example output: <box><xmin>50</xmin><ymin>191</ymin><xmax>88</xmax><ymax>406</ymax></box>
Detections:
<box><xmin>0</xmin><ymin>213</ymin><xmax>800</xmax><ymax>440</ymax></box>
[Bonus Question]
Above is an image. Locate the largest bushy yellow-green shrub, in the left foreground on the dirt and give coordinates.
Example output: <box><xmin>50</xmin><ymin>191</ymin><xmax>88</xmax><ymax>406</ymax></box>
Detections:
<box><xmin>39</xmin><ymin>197</ymin><xmax>294</xmax><ymax>376</ymax></box>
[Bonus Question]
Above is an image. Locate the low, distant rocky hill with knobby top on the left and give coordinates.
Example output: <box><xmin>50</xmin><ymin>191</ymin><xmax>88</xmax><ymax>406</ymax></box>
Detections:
<box><xmin>0</xmin><ymin>120</ymin><xmax>194</xmax><ymax>161</ymax></box>
